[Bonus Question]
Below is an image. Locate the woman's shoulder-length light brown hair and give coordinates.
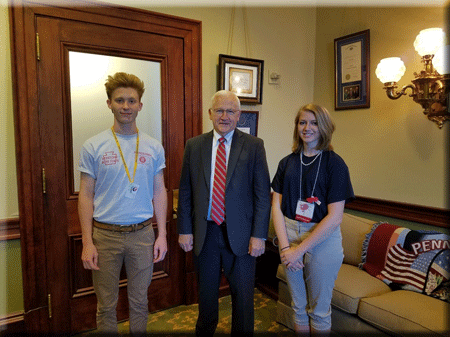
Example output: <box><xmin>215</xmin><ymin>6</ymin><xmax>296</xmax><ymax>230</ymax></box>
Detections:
<box><xmin>292</xmin><ymin>103</ymin><xmax>335</xmax><ymax>153</ymax></box>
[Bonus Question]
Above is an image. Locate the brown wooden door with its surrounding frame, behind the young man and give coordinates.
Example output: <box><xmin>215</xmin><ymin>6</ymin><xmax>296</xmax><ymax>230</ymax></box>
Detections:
<box><xmin>9</xmin><ymin>0</ymin><xmax>202</xmax><ymax>333</ymax></box>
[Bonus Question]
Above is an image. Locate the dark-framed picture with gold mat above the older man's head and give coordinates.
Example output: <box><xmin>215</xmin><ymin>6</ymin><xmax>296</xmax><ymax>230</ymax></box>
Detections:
<box><xmin>219</xmin><ymin>54</ymin><xmax>264</xmax><ymax>104</ymax></box>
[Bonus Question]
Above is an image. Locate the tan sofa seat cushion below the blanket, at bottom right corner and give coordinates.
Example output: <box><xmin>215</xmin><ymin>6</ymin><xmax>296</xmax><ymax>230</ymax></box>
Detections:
<box><xmin>358</xmin><ymin>290</ymin><xmax>450</xmax><ymax>336</ymax></box>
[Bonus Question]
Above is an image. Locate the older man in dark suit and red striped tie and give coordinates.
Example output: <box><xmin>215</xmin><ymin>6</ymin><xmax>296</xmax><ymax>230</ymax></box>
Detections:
<box><xmin>178</xmin><ymin>90</ymin><xmax>270</xmax><ymax>336</ymax></box>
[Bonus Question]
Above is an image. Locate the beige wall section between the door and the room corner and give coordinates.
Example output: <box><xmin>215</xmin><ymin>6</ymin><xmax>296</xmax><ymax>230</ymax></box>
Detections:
<box><xmin>132</xmin><ymin>7</ymin><xmax>316</xmax><ymax>176</ymax></box>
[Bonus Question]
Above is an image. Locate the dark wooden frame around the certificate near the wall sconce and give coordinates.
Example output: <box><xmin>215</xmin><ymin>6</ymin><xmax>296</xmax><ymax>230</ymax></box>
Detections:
<box><xmin>334</xmin><ymin>29</ymin><xmax>370</xmax><ymax>110</ymax></box>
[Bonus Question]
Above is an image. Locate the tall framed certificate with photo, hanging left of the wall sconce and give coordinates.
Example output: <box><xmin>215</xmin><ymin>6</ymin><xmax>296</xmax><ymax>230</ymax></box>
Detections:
<box><xmin>334</xmin><ymin>29</ymin><xmax>370</xmax><ymax>110</ymax></box>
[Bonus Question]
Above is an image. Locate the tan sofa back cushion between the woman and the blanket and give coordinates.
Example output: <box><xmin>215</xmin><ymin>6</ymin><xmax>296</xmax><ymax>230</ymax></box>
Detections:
<box><xmin>341</xmin><ymin>213</ymin><xmax>375</xmax><ymax>266</ymax></box>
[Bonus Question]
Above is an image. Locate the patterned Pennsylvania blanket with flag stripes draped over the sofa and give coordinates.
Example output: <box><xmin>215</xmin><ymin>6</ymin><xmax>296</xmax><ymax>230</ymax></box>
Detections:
<box><xmin>359</xmin><ymin>222</ymin><xmax>450</xmax><ymax>302</ymax></box>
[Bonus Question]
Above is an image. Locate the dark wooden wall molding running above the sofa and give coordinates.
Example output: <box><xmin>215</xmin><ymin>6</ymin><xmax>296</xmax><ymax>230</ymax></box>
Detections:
<box><xmin>345</xmin><ymin>196</ymin><xmax>450</xmax><ymax>228</ymax></box>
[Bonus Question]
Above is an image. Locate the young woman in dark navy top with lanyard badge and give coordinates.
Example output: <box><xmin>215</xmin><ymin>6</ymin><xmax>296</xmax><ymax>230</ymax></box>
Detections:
<box><xmin>272</xmin><ymin>104</ymin><xmax>354</xmax><ymax>336</ymax></box>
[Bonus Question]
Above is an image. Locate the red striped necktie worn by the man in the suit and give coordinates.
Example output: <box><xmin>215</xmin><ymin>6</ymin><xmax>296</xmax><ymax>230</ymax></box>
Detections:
<box><xmin>211</xmin><ymin>137</ymin><xmax>227</xmax><ymax>226</ymax></box>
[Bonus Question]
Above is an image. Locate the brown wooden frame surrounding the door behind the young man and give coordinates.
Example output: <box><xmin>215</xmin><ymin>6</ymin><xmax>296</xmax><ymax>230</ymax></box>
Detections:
<box><xmin>9</xmin><ymin>0</ymin><xmax>202</xmax><ymax>332</ymax></box>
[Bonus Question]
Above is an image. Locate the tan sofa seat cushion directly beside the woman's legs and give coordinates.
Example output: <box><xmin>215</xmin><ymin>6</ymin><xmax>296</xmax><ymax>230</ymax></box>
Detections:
<box><xmin>331</xmin><ymin>263</ymin><xmax>392</xmax><ymax>314</ymax></box>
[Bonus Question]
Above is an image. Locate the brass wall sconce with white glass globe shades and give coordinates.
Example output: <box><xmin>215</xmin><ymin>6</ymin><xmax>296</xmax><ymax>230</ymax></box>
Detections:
<box><xmin>375</xmin><ymin>28</ymin><xmax>450</xmax><ymax>128</ymax></box>
